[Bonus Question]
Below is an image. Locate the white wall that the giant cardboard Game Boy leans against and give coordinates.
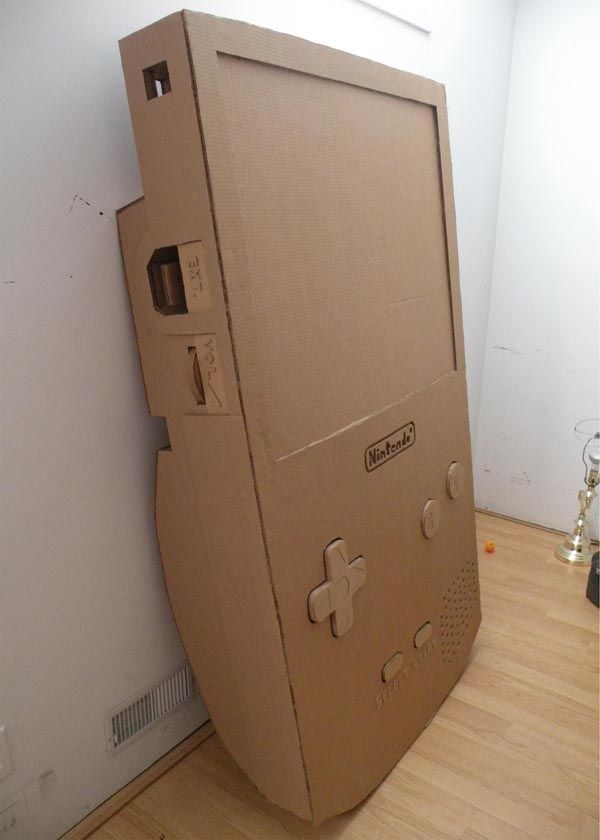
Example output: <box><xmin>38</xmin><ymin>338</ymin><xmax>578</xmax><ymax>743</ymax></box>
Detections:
<box><xmin>0</xmin><ymin>0</ymin><xmax>514</xmax><ymax>840</ymax></box>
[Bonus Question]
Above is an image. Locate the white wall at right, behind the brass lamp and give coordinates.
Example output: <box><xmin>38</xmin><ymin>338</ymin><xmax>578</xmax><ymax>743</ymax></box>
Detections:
<box><xmin>476</xmin><ymin>0</ymin><xmax>600</xmax><ymax>533</ymax></box>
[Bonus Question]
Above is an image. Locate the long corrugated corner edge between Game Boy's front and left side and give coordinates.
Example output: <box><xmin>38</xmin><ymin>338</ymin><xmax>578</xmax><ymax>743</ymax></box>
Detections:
<box><xmin>181</xmin><ymin>11</ymin><xmax>314</xmax><ymax>822</ymax></box>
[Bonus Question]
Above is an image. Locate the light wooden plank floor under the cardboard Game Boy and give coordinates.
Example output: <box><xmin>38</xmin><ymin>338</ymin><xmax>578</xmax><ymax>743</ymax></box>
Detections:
<box><xmin>92</xmin><ymin>514</ymin><xmax>598</xmax><ymax>840</ymax></box>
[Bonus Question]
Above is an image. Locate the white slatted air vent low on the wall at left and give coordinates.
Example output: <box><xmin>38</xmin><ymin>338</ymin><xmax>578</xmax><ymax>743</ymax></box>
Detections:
<box><xmin>106</xmin><ymin>663</ymin><xmax>198</xmax><ymax>756</ymax></box>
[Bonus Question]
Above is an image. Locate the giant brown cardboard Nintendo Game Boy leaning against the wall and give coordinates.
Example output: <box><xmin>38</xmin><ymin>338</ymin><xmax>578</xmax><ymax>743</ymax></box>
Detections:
<box><xmin>119</xmin><ymin>12</ymin><xmax>480</xmax><ymax>822</ymax></box>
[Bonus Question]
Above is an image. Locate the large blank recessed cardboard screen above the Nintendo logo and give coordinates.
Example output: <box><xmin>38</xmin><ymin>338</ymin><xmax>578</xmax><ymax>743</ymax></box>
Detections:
<box><xmin>218</xmin><ymin>56</ymin><xmax>454</xmax><ymax>457</ymax></box>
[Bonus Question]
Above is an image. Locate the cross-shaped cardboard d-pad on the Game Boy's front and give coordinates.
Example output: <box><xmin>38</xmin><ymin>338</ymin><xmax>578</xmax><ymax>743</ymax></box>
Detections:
<box><xmin>308</xmin><ymin>539</ymin><xmax>367</xmax><ymax>636</ymax></box>
